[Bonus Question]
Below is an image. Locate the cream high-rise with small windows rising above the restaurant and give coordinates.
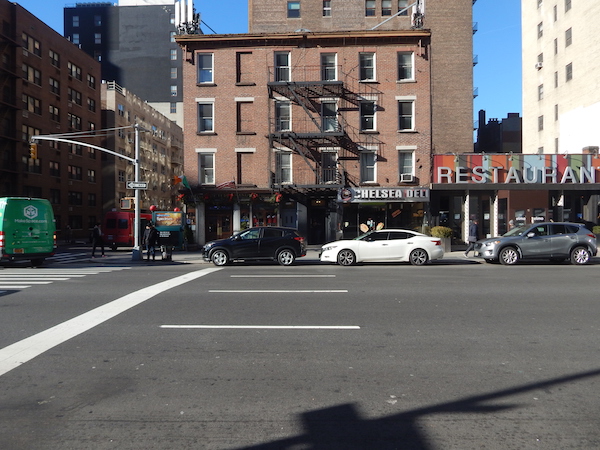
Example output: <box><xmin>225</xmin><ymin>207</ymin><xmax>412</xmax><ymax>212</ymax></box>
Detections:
<box><xmin>521</xmin><ymin>0</ymin><xmax>600</xmax><ymax>154</ymax></box>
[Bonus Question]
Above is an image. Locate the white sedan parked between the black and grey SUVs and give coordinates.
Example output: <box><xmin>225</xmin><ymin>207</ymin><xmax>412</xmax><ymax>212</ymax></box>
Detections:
<box><xmin>320</xmin><ymin>229</ymin><xmax>444</xmax><ymax>266</ymax></box>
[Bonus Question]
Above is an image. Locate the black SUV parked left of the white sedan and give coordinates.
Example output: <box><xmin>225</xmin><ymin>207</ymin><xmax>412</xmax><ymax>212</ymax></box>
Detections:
<box><xmin>203</xmin><ymin>227</ymin><xmax>306</xmax><ymax>266</ymax></box>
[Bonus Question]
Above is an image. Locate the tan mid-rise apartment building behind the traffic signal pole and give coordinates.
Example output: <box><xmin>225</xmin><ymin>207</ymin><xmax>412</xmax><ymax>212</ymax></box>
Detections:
<box><xmin>101</xmin><ymin>82</ymin><xmax>183</xmax><ymax>211</ymax></box>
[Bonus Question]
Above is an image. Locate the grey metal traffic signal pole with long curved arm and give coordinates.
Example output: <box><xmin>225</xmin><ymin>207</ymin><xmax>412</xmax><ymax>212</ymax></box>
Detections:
<box><xmin>30</xmin><ymin>124</ymin><xmax>145</xmax><ymax>261</ymax></box>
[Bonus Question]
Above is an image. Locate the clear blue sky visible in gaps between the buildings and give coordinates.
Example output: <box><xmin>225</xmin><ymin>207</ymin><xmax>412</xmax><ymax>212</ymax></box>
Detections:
<box><xmin>17</xmin><ymin>0</ymin><xmax>522</xmax><ymax>120</ymax></box>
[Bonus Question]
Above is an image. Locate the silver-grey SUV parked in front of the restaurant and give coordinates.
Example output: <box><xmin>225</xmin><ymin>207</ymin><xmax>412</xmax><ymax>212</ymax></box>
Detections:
<box><xmin>475</xmin><ymin>222</ymin><xmax>597</xmax><ymax>265</ymax></box>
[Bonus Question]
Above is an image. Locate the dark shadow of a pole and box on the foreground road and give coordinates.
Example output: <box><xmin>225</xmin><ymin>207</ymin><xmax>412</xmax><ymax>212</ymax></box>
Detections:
<box><xmin>232</xmin><ymin>369</ymin><xmax>600</xmax><ymax>450</ymax></box>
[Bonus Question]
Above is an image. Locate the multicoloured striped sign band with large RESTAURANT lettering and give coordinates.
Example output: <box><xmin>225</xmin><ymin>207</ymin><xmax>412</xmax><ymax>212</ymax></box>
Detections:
<box><xmin>433</xmin><ymin>153</ymin><xmax>600</xmax><ymax>184</ymax></box>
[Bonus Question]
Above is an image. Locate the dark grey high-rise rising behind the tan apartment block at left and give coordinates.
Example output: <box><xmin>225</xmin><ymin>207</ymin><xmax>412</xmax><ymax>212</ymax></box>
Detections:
<box><xmin>64</xmin><ymin>0</ymin><xmax>191</xmax><ymax>126</ymax></box>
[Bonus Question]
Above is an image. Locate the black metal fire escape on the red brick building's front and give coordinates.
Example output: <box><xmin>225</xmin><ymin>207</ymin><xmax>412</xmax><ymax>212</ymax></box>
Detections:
<box><xmin>268</xmin><ymin>64</ymin><xmax>382</xmax><ymax>199</ymax></box>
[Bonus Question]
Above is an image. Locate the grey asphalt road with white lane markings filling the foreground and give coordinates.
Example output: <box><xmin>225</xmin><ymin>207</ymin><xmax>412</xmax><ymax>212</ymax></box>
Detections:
<box><xmin>0</xmin><ymin>260</ymin><xmax>600</xmax><ymax>450</ymax></box>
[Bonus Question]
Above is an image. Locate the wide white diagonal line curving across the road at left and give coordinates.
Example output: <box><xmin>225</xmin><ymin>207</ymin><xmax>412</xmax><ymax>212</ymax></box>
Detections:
<box><xmin>0</xmin><ymin>268</ymin><xmax>221</xmax><ymax>376</ymax></box>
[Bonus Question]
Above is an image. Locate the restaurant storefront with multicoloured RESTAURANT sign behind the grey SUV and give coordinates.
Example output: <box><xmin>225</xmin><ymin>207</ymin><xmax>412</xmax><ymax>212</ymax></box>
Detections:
<box><xmin>431</xmin><ymin>154</ymin><xmax>600</xmax><ymax>242</ymax></box>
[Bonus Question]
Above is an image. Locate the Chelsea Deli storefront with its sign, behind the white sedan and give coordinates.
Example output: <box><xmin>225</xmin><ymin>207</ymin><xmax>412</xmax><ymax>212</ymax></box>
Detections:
<box><xmin>338</xmin><ymin>188</ymin><xmax>429</xmax><ymax>239</ymax></box>
